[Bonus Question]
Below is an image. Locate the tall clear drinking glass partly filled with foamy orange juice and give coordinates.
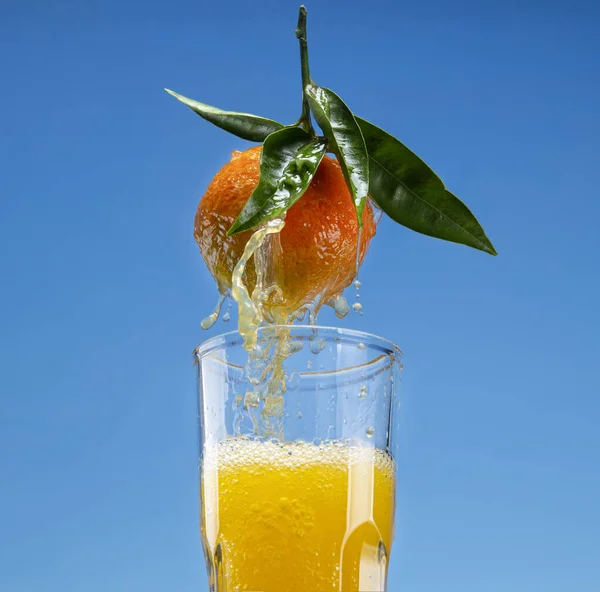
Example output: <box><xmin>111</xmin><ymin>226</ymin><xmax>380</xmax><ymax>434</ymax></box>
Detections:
<box><xmin>194</xmin><ymin>326</ymin><xmax>401</xmax><ymax>592</ymax></box>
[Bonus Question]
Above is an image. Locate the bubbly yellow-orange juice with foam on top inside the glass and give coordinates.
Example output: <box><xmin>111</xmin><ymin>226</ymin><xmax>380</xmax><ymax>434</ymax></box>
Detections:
<box><xmin>201</xmin><ymin>438</ymin><xmax>395</xmax><ymax>592</ymax></box>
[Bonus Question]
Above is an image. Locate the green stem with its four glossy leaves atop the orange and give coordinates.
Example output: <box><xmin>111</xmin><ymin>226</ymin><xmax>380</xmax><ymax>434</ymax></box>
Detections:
<box><xmin>165</xmin><ymin>6</ymin><xmax>497</xmax><ymax>255</ymax></box>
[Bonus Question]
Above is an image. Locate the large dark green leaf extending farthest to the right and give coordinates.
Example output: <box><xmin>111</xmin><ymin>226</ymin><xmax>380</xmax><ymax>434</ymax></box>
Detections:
<box><xmin>356</xmin><ymin>117</ymin><xmax>497</xmax><ymax>255</ymax></box>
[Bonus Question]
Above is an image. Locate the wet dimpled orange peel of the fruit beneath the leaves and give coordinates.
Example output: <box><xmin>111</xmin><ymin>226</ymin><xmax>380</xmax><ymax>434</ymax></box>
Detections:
<box><xmin>194</xmin><ymin>146</ymin><xmax>376</xmax><ymax>320</ymax></box>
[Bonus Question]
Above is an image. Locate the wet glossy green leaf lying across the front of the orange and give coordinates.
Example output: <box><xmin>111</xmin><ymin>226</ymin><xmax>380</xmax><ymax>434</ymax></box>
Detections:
<box><xmin>227</xmin><ymin>127</ymin><xmax>327</xmax><ymax>236</ymax></box>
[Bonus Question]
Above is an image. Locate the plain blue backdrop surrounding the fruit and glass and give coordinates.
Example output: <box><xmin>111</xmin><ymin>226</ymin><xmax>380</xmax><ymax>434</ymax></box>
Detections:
<box><xmin>0</xmin><ymin>0</ymin><xmax>600</xmax><ymax>592</ymax></box>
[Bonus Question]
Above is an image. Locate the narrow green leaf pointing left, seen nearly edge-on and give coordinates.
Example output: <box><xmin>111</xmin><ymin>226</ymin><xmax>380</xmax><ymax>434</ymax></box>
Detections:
<box><xmin>165</xmin><ymin>88</ymin><xmax>283</xmax><ymax>142</ymax></box>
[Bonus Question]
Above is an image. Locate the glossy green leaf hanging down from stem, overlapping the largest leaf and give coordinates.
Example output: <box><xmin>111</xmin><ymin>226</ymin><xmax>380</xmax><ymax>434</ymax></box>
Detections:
<box><xmin>305</xmin><ymin>84</ymin><xmax>369</xmax><ymax>227</ymax></box>
